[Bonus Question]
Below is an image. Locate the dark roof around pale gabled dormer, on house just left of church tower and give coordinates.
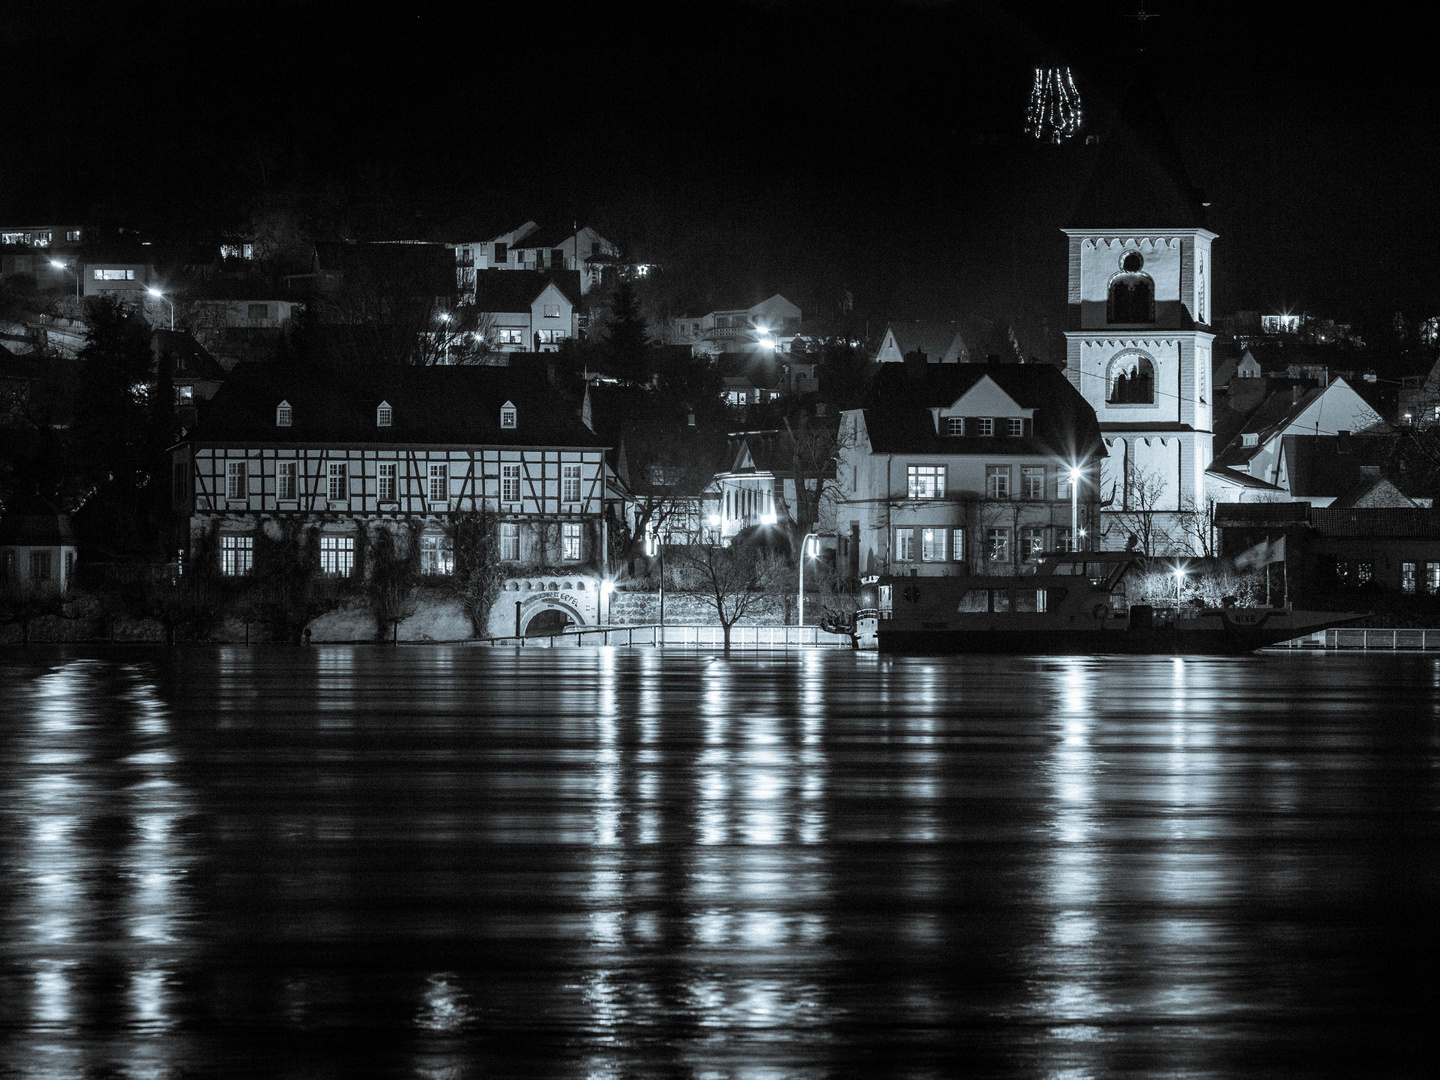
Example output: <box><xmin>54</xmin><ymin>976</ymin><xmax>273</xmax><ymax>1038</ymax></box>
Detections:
<box><xmin>864</xmin><ymin>364</ymin><xmax>1106</xmax><ymax>461</ymax></box>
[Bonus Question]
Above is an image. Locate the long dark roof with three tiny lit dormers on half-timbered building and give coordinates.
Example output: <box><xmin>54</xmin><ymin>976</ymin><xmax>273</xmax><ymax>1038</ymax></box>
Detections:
<box><xmin>189</xmin><ymin>364</ymin><xmax>603</xmax><ymax>446</ymax></box>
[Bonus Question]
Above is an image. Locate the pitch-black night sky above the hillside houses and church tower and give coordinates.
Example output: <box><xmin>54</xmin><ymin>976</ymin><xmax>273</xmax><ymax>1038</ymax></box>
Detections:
<box><xmin>0</xmin><ymin>0</ymin><xmax>1440</xmax><ymax>342</ymax></box>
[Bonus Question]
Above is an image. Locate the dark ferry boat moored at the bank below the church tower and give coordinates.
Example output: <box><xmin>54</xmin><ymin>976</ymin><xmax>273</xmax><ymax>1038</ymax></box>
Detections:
<box><xmin>876</xmin><ymin>552</ymin><xmax>1365</xmax><ymax>655</ymax></box>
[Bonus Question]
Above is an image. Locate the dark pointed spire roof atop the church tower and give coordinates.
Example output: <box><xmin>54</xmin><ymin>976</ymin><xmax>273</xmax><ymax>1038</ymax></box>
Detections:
<box><xmin>1070</xmin><ymin>68</ymin><xmax>1205</xmax><ymax>229</ymax></box>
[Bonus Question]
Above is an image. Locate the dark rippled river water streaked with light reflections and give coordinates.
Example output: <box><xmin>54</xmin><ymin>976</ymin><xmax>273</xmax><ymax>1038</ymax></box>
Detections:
<box><xmin>0</xmin><ymin>647</ymin><xmax>1440</xmax><ymax>1080</ymax></box>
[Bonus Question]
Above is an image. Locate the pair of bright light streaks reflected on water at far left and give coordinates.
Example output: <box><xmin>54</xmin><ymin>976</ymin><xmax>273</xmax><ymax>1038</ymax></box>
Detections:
<box><xmin>3</xmin><ymin>660</ymin><xmax>193</xmax><ymax>1076</ymax></box>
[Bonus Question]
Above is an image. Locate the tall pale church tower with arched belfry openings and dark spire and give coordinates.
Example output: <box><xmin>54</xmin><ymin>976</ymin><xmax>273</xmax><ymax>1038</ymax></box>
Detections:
<box><xmin>1064</xmin><ymin>75</ymin><xmax>1215</xmax><ymax>553</ymax></box>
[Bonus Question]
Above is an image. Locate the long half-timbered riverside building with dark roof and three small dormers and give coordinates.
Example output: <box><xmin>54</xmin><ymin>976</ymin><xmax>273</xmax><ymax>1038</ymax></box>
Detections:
<box><xmin>174</xmin><ymin>364</ymin><xmax>619</xmax><ymax>635</ymax></box>
